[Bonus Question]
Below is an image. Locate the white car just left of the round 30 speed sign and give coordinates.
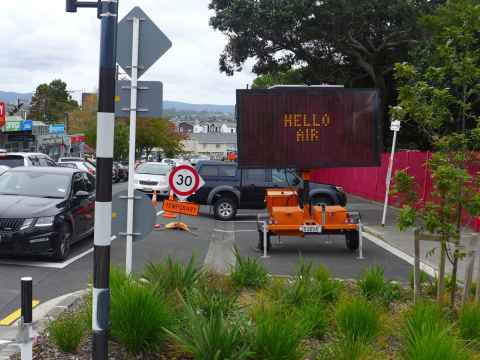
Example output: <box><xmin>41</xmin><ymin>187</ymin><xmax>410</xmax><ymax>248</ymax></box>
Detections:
<box><xmin>134</xmin><ymin>162</ymin><xmax>171</xmax><ymax>196</ymax></box>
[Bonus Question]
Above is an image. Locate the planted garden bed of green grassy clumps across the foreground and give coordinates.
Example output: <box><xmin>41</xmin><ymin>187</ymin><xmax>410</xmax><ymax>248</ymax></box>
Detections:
<box><xmin>13</xmin><ymin>254</ymin><xmax>480</xmax><ymax>360</ymax></box>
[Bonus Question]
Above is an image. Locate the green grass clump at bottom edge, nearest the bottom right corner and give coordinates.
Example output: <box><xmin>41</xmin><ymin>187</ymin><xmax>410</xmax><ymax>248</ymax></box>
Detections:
<box><xmin>402</xmin><ymin>302</ymin><xmax>468</xmax><ymax>360</ymax></box>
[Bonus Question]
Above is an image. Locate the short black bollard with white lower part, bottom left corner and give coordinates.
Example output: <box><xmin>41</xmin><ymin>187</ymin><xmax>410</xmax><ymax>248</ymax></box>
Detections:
<box><xmin>18</xmin><ymin>277</ymin><xmax>33</xmax><ymax>360</ymax></box>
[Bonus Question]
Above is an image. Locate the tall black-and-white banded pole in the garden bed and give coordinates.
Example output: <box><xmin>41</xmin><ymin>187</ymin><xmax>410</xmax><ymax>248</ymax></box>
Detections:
<box><xmin>66</xmin><ymin>0</ymin><xmax>118</xmax><ymax>360</ymax></box>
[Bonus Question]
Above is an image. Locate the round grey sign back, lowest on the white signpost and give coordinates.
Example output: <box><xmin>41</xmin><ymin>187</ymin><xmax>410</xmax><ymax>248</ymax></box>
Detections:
<box><xmin>112</xmin><ymin>190</ymin><xmax>156</xmax><ymax>241</ymax></box>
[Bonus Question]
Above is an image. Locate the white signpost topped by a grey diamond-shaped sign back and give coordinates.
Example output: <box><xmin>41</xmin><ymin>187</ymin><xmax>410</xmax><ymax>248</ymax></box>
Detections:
<box><xmin>116</xmin><ymin>6</ymin><xmax>172</xmax><ymax>274</ymax></box>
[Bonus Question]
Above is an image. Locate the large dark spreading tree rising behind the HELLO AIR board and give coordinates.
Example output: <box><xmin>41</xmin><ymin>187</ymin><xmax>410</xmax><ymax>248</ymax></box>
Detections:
<box><xmin>209</xmin><ymin>0</ymin><xmax>440</xmax><ymax>143</ymax></box>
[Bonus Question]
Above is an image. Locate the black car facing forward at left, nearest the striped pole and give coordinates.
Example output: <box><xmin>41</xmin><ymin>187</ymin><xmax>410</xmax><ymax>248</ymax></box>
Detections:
<box><xmin>0</xmin><ymin>167</ymin><xmax>95</xmax><ymax>260</ymax></box>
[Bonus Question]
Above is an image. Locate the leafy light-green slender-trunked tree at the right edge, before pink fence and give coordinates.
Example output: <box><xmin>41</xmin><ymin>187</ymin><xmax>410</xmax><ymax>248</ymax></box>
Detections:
<box><xmin>393</xmin><ymin>0</ymin><xmax>480</xmax><ymax>306</ymax></box>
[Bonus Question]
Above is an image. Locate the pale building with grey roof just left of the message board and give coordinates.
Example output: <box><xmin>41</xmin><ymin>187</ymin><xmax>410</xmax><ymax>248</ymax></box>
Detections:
<box><xmin>183</xmin><ymin>132</ymin><xmax>237</xmax><ymax>160</ymax></box>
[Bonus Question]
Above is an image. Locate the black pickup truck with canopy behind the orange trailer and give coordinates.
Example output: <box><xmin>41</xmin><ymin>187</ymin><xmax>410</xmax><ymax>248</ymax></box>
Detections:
<box><xmin>189</xmin><ymin>161</ymin><xmax>347</xmax><ymax>221</ymax></box>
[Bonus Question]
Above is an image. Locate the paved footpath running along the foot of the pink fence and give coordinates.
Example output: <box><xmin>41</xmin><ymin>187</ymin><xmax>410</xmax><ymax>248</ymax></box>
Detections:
<box><xmin>347</xmin><ymin>195</ymin><xmax>480</xmax><ymax>282</ymax></box>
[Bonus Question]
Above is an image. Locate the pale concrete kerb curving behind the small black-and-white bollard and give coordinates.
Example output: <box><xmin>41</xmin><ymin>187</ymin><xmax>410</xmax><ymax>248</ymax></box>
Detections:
<box><xmin>0</xmin><ymin>289</ymin><xmax>89</xmax><ymax>360</ymax></box>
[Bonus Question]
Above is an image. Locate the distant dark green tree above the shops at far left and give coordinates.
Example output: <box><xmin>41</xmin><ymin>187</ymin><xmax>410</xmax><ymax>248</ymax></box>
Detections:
<box><xmin>30</xmin><ymin>79</ymin><xmax>78</xmax><ymax>123</ymax></box>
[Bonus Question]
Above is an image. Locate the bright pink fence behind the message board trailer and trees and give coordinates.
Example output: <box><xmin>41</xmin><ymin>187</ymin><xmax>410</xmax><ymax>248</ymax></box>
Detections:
<box><xmin>312</xmin><ymin>151</ymin><xmax>480</xmax><ymax>231</ymax></box>
